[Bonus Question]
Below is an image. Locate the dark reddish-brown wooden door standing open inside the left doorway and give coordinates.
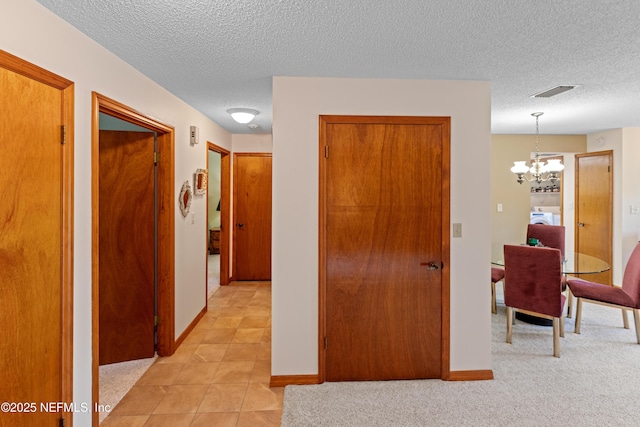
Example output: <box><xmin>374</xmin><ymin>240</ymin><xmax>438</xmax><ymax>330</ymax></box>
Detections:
<box><xmin>99</xmin><ymin>131</ymin><xmax>155</xmax><ymax>365</ymax></box>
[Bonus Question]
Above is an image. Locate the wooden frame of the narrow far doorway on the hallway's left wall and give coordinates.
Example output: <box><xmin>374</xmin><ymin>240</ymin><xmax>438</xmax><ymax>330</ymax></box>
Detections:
<box><xmin>205</xmin><ymin>141</ymin><xmax>231</xmax><ymax>288</ymax></box>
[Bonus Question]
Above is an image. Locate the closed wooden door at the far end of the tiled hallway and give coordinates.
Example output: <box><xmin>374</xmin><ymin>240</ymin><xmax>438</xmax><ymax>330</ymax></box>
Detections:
<box><xmin>233</xmin><ymin>154</ymin><xmax>271</xmax><ymax>280</ymax></box>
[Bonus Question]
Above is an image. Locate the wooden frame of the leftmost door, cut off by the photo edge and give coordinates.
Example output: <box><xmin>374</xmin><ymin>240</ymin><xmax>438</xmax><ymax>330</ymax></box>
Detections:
<box><xmin>0</xmin><ymin>49</ymin><xmax>75</xmax><ymax>425</ymax></box>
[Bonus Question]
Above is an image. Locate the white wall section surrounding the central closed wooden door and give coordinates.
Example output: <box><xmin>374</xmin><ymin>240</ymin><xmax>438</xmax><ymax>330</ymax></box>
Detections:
<box><xmin>272</xmin><ymin>77</ymin><xmax>491</xmax><ymax>375</ymax></box>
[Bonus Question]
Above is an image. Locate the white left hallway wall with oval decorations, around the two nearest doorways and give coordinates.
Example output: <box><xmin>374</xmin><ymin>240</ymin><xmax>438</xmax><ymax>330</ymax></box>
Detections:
<box><xmin>0</xmin><ymin>0</ymin><xmax>231</xmax><ymax>426</ymax></box>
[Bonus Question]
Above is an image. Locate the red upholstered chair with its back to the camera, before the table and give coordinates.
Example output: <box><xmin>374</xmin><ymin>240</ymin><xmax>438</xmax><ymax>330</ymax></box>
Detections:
<box><xmin>504</xmin><ymin>245</ymin><xmax>566</xmax><ymax>357</ymax></box>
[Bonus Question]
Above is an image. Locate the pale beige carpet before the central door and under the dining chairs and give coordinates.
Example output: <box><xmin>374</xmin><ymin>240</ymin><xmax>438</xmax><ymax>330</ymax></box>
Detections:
<box><xmin>282</xmin><ymin>286</ymin><xmax>640</xmax><ymax>427</ymax></box>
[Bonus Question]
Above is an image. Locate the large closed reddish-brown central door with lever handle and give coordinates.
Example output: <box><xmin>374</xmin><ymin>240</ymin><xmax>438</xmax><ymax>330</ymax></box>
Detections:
<box><xmin>321</xmin><ymin>117</ymin><xmax>449</xmax><ymax>381</ymax></box>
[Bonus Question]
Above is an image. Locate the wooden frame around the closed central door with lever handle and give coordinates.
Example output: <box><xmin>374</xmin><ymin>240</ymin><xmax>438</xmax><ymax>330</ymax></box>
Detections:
<box><xmin>318</xmin><ymin>115</ymin><xmax>452</xmax><ymax>383</ymax></box>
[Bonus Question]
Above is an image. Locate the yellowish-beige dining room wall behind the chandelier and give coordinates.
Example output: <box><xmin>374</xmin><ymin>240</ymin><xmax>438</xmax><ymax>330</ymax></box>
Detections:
<box><xmin>491</xmin><ymin>135</ymin><xmax>587</xmax><ymax>247</ymax></box>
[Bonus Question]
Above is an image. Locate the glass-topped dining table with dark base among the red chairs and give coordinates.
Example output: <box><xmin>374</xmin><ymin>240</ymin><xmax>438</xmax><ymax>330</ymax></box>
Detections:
<box><xmin>491</xmin><ymin>243</ymin><xmax>611</xmax><ymax>326</ymax></box>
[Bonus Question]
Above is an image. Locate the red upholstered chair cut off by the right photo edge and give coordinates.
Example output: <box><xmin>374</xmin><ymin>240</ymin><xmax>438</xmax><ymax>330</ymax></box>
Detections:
<box><xmin>568</xmin><ymin>244</ymin><xmax>640</xmax><ymax>344</ymax></box>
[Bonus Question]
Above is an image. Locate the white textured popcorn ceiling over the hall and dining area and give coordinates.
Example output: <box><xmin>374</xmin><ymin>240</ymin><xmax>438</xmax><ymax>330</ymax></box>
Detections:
<box><xmin>33</xmin><ymin>0</ymin><xmax>640</xmax><ymax>134</ymax></box>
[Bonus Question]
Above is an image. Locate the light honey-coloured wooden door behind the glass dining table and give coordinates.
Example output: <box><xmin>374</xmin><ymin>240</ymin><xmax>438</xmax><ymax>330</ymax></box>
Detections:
<box><xmin>575</xmin><ymin>151</ymin><xmax>613</xmax><ymax>285</ymax></box>
